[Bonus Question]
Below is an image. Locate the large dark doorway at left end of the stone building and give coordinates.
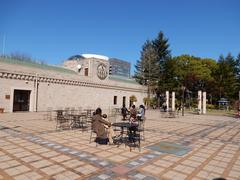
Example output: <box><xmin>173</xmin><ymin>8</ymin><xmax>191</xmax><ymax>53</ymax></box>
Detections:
<box><xmin>13</xmin><ymin>90</ymin><xmax>31</xmax><ymax>112</ymax></box>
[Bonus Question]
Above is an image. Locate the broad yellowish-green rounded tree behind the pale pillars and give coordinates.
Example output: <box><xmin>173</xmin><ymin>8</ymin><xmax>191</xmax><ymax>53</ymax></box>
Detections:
<box><xmin>172</xmin><ymin>55</ymin><xmax>217</xmax><ymax>105</ymax></box>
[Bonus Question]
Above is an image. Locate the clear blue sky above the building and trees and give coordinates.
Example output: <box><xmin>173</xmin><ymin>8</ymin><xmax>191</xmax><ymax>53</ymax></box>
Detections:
<box><xmin>0</xmin><ymin>0</ymin><xmax>240</xmax><ymax>74</ymax></box>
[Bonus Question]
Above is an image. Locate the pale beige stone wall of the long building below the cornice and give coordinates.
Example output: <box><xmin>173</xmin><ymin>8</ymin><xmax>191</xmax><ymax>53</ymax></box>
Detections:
<box><xmin>0</xmin><ymin>78</ymin><xmax>147</xmax><ymax>112</ymax></box>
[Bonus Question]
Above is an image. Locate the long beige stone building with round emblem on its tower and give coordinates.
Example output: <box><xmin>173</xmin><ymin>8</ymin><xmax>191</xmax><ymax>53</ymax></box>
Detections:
<box><xmin>0</xmin><ymin>54</ymin><xmax>147</xmax><ymax>112</ymax></box>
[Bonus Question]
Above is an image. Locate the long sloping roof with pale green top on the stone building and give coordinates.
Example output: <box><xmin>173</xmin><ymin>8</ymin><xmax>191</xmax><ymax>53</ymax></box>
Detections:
<box><xmin>0</xmin><ymin>57</ymin><xmax>144</xmax><ymax>90</ymax></box>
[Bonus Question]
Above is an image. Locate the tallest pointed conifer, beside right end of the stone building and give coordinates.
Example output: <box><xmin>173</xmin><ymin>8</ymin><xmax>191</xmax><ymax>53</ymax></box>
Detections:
<box><xmin>134</xmin><ymin>32</ymin><xmax>171</xmax><ymax>106</ymax></box>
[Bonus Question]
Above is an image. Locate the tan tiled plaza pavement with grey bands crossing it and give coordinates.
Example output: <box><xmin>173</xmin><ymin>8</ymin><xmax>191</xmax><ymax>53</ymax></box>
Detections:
<box><xmin>0</xmin><ymin>111</ymin><xmax>240</xmax><ymax>180</ymax></box>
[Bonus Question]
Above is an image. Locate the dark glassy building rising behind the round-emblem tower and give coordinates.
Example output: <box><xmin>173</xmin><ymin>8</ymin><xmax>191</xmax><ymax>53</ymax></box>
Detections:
<box><xmin>109</xmin><ymin>58</ymin><xmax>131</xmax><ymax>78</ymax></box>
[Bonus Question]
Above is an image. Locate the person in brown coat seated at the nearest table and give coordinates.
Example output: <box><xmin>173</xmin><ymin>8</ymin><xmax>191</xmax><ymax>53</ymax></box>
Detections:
<box><xmin>92</xmin><ymin>108</ymin><xmax>111</xmax><ymax>144</ymax></box>
